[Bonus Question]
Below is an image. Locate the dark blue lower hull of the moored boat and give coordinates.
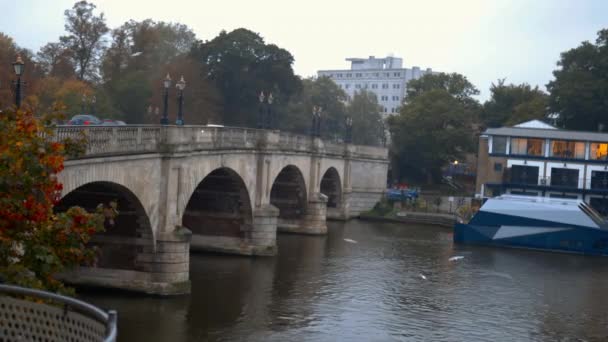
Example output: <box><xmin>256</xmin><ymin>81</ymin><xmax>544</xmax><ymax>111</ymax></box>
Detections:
<box><xmin>454</xmin><ymin>223</ymin><xmax>608</xmax><ymax>255</ymax></box>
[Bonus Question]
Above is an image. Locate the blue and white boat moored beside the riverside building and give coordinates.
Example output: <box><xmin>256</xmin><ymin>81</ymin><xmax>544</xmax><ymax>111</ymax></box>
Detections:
<box><xmin>454</xmin><ymin>195</ymin><xmax>608</xmax><ymax>255</ymax></box>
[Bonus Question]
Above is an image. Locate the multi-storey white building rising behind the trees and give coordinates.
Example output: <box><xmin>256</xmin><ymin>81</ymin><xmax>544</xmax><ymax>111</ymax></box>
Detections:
<box><xmin>317</xmin><ymin>56</ymin><xmax>432</xmax><ymax>116</ymax></box>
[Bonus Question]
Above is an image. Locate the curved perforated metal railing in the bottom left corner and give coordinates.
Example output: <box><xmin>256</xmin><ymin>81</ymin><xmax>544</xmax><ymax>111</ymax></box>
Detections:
<box><xmin>0</xmin><ymin>284</ymin><xmax>117</xmax><ymax>342</ymax></box>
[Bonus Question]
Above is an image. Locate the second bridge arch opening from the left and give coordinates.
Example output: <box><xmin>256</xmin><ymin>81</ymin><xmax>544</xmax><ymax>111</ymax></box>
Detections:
<box><xmin>182</xmin><ymin>167</ymin><xmax>253</xmax><ymax>251</ymax></box>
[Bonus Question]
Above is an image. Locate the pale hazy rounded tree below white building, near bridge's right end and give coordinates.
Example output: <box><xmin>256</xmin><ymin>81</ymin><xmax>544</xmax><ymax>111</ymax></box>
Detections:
<box><xmin>346</xmin><ymin>90</ymin><xmax>385</xmax><ymax>145</ymax></box>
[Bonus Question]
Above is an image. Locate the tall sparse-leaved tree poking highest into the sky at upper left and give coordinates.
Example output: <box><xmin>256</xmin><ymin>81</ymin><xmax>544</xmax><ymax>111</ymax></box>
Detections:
<box><xmin>59</xmin><ymin>1</ymin><xmax>109</xmax><ymax>80</ymax></box>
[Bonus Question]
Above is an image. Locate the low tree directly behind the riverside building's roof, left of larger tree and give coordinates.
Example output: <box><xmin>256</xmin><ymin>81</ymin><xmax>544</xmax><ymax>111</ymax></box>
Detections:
<box><xmin>481</xmin><ymin>79</ymin><xmax>549</xmax><ymax>127</ymax></box>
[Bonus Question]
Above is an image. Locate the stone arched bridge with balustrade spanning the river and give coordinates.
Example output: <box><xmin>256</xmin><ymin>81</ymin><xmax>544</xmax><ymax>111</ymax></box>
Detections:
<box><xmin>56</xmin><ymin>126</ymin><xmax>388</xmax><ymax>294</ymax></box>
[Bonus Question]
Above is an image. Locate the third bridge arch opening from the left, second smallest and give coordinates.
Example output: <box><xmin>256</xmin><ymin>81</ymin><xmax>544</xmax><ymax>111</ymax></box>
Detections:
<box><xmin>270</xmin><ymin>164</ymin><xmax>308</xmax><ymax>227</ymax></box>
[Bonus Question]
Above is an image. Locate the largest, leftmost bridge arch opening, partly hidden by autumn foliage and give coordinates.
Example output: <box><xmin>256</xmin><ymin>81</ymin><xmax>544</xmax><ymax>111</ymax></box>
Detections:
<box><xmin>55</xmin><ymin>181</ymin><xmax>155</xmax><ymax>271</ymax></box>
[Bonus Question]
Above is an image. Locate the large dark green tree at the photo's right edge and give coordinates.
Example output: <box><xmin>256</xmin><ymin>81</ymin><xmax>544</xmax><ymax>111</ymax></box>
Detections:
<box><xmin>547</xmin><ymin>29</ymin><xmax>608</xmax><ymax>131</ymax></box>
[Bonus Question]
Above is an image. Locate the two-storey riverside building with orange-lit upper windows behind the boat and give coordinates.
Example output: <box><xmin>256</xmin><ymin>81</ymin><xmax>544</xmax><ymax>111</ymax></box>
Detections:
<box><xmin>476</xmin><ymin>120</ymin><xmax>608</xmax><ymax>216</ymax></box>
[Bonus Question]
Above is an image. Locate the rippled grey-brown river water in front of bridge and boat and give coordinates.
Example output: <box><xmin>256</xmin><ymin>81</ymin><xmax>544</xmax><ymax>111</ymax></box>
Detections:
<box><xmin>82</xmin><ymin>221</ymin><xmax>608</xmax><ymax>342</ymax></box>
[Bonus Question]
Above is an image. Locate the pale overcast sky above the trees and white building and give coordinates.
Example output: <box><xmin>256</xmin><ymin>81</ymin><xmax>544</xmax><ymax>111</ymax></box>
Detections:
<box><xmin>0</xmin><ymin>0</ymin><xmax>608</xmax><ymax>99</ymax></box>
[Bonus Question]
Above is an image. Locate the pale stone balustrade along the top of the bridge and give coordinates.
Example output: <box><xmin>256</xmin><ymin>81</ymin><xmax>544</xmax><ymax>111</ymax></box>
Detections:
<box><xmin>54</xmin><ymin>125</ymin><xmax>387</xmax><ymax>159</ymax></box>
